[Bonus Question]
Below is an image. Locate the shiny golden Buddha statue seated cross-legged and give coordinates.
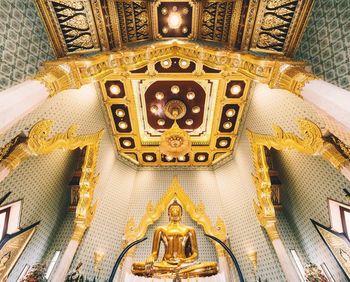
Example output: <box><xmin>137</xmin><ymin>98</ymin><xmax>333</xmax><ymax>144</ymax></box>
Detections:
<box><xmin>132</xmin><ymin>200</ymin><xmax>218</xmax><ymax>278</ymax></box>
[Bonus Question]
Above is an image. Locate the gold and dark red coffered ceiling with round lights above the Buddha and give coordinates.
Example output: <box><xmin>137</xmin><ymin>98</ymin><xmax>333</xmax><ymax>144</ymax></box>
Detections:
<box><xmin>100</xmin><ymin>57</ymin><xmax>251</xmax><ymax>166</ymax></box>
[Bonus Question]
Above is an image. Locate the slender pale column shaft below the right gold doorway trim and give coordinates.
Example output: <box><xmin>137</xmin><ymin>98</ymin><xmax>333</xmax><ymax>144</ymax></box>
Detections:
<box><xmin>271</xmin><ymin>239</ymin><xmax>302</xmax><ymax>282</ymax></box>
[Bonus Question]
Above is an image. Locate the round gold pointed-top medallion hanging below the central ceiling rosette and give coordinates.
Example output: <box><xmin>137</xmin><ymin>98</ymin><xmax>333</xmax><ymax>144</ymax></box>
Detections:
<box><xmin>159</xmin><ymin>120</ymin><xmax>191</xmax><ymax>158</ymax></box>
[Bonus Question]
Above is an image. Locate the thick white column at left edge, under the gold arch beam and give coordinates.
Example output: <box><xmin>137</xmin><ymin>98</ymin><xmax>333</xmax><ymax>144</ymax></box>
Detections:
<box><xmin>0</xmin><ymin>80</ymin><xmax>49</xmax><ymax>134</ymax></box>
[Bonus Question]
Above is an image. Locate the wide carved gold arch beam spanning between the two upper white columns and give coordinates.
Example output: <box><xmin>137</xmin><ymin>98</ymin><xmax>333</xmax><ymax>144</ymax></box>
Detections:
<box><xmin>34</xmin><ymin>39</ymin><xmax>317</xmax><ymax>96</ymax></box>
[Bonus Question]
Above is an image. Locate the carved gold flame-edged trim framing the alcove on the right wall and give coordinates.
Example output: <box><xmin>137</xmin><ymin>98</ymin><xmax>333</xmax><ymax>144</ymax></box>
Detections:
<box><xmin>247</xmin><ymin>119</ymin><xmax>349</xmax><ymax>240</ymax></box>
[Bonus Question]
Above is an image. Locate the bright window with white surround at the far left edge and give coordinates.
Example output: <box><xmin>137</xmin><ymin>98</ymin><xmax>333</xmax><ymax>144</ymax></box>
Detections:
<box><xmin>0</xmin><ymin>201</ymin><xmax>22</xmax><ymax>240</ymax></box>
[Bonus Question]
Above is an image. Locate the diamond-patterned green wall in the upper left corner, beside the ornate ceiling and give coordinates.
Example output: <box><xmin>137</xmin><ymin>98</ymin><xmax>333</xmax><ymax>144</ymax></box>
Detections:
<box><xmin>0</xmin><ymin>0</ymin><xmax>54</xmax><ymax>90</ymax></box>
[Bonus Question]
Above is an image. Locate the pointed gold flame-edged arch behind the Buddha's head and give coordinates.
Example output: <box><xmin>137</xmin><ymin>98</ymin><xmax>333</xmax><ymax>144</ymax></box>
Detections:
<box><xmin>124</xmin><ymin>176</ymin><xmax>227</xmax><ymax>256</ymax></box>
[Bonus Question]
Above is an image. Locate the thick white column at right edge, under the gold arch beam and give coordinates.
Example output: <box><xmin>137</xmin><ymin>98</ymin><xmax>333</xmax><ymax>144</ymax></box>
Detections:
<box><xmin>301</xmin><ymin>80</ymin><xmax>350</xmax><ymax>133</ymax></box>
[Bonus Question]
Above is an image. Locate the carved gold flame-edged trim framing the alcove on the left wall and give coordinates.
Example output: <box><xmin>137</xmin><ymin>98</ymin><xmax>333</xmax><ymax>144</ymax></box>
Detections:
<box><xmin>0</xmin><ymin>120</ymin><xmax>104</xmax><ymax>241</ymax></box>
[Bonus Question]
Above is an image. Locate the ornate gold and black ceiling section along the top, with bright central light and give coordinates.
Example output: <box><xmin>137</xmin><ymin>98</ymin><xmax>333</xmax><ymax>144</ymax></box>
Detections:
<box><xmin>36</xmin><ymin>0</ymin><xmax>313</xmax><ymax>56</ymax></box>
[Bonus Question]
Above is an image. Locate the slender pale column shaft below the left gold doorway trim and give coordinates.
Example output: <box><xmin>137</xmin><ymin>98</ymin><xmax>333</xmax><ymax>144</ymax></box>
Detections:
<box><xmin>51</xmin><ymin>240</ymin><xmax>80</xmax><ymax>282</ymax></box>
